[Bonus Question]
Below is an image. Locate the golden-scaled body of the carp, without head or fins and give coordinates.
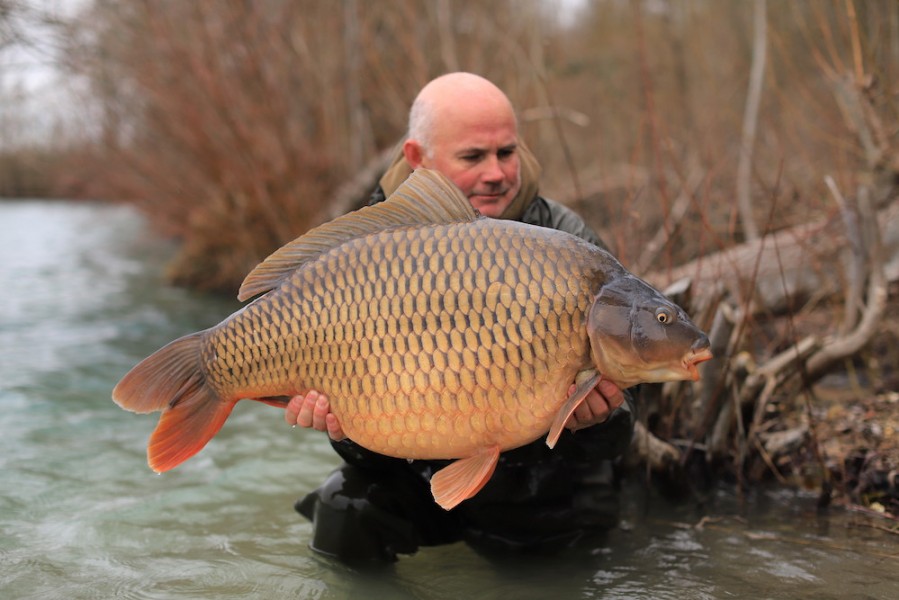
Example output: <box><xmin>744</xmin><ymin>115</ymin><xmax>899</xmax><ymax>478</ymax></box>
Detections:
<box><xmin>204</xmin><ymin>220</ymin><xmax>594</xmax><ymax>458</ymax></box>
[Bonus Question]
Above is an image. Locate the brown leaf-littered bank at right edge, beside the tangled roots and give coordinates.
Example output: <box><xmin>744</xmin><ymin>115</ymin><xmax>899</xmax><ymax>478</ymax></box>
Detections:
<box><xmin>708</xmin><ymin>283</ymin><xmax>899</xmax><ymax>533</ymax></box>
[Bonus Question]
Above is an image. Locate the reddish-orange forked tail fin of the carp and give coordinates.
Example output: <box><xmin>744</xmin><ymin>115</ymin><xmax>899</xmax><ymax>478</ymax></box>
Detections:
<box><xmin>112</xmin><ymin>332</ymin><xmax>237</xmax><ymax>473</ymax></box>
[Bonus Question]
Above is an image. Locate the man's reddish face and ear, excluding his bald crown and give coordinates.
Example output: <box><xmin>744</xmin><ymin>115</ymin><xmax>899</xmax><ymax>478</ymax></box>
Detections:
<box><xmin>412</xmin><ymin>106</ymin><xmax>521</xmax><ymax>217</ymax></box>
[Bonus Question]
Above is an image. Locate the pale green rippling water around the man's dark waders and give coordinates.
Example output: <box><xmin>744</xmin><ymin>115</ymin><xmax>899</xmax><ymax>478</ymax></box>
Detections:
<box><xmin>0</xmin><ymin>201</ymin><xmax>899</xmax><ymax>599</ymax></box>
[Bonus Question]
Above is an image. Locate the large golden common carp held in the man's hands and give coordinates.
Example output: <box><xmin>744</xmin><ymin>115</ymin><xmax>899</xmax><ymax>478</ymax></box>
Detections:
<box><xmin>113</xmin><ymin>170</ymin><xmax>711</xmax><ymax>509</ymax></box>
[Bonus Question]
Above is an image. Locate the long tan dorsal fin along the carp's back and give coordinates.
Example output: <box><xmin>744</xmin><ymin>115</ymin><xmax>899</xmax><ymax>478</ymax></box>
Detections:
<box><xmin>237</xmin><ymin>169</ymin><xmax>478</xmax><ymax>301</ymax></box>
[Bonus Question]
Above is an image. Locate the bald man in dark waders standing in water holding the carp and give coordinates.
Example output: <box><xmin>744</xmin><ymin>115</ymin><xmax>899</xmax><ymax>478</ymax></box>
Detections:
<box><xmin>285</xmin><ymin>73</ymin><xmax>633</xmax><ymax>563</ymax></box>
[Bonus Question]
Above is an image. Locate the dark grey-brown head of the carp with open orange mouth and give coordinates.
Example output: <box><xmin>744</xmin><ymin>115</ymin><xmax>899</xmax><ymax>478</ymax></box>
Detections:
<box><xmin>587</xmin><ymin>274</ymin><xmax>712</xmax><ymax>389</ymax></box>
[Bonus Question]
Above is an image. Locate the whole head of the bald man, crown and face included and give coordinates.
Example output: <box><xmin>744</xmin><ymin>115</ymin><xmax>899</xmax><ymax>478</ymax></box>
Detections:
<box><xmin>403</xmin><ymin>73</ymin><xmax>521</xmax><ymax>217</ymax></box>
